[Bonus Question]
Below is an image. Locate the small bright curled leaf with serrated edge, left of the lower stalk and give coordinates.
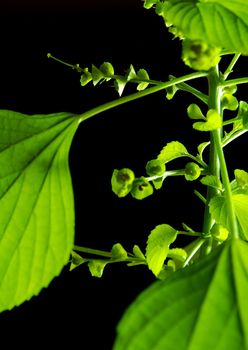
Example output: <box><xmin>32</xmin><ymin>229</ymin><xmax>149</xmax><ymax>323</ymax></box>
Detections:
<box><xmin>146</xmin><ymin>224</ymin><xmax>177</xmax><ymax>276</ymax></box>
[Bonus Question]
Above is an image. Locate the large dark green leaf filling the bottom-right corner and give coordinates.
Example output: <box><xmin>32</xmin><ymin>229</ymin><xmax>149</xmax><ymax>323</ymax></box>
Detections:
<box><xmin>114</xmin><ymin>240</ymin><xmax>248</xmax><ymax>350</ymax></box>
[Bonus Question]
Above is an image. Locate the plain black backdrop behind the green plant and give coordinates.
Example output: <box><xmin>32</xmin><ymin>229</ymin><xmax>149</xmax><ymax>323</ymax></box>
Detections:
<box><xmin>0</xmin><ymin>0</ymin><xmax>247</xmax><ymax>350</ymax></box>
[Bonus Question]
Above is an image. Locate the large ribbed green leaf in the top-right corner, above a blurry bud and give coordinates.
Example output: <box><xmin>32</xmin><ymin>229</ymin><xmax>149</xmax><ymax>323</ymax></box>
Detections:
<box><xmin>162</xmin><ymin>0</ymin><xmax>248</xmax><ymax>54</ymax></box>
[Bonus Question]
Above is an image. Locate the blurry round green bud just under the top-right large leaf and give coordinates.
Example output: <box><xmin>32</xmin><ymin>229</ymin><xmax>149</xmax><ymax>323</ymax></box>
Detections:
<box><xmin>182</xmin><ymin>39</ymin><xmax>221</xmax><ymax>71</ymax></box>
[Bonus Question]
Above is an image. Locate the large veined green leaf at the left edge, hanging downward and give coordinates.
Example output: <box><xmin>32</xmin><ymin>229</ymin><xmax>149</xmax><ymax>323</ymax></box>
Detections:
<box><xmin>0</xmin><ymin>110</ymin><xmax>78</xmax><ymax>311</ymax></box>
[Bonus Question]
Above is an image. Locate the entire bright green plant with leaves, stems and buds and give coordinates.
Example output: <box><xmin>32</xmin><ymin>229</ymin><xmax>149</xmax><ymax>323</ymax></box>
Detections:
<box><xmin>0</xmin><ymin>0</ymin><xmax>248</xmax><ymax>350</ymax></box>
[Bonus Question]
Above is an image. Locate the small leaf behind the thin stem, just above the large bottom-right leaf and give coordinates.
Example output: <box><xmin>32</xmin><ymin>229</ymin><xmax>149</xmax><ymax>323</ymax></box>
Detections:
<box><xmin>209</xmin><ymin>193</ymin><xmax>248</xmax><ymax>239</ymax></box>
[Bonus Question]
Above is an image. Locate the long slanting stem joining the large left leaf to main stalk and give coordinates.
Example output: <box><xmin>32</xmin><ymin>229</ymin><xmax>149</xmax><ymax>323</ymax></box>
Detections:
<box><xmin>78</xmin><ymin>72</ymin><xmax>207</xmax><ymax>122</ymax></box>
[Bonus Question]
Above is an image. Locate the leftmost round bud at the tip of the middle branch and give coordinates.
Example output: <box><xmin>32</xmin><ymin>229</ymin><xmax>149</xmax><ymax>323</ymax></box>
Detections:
<box><xmin>111</xmin><ymin>168</ymin><xmax>135</xmax><ymax>197</ymax></box>
